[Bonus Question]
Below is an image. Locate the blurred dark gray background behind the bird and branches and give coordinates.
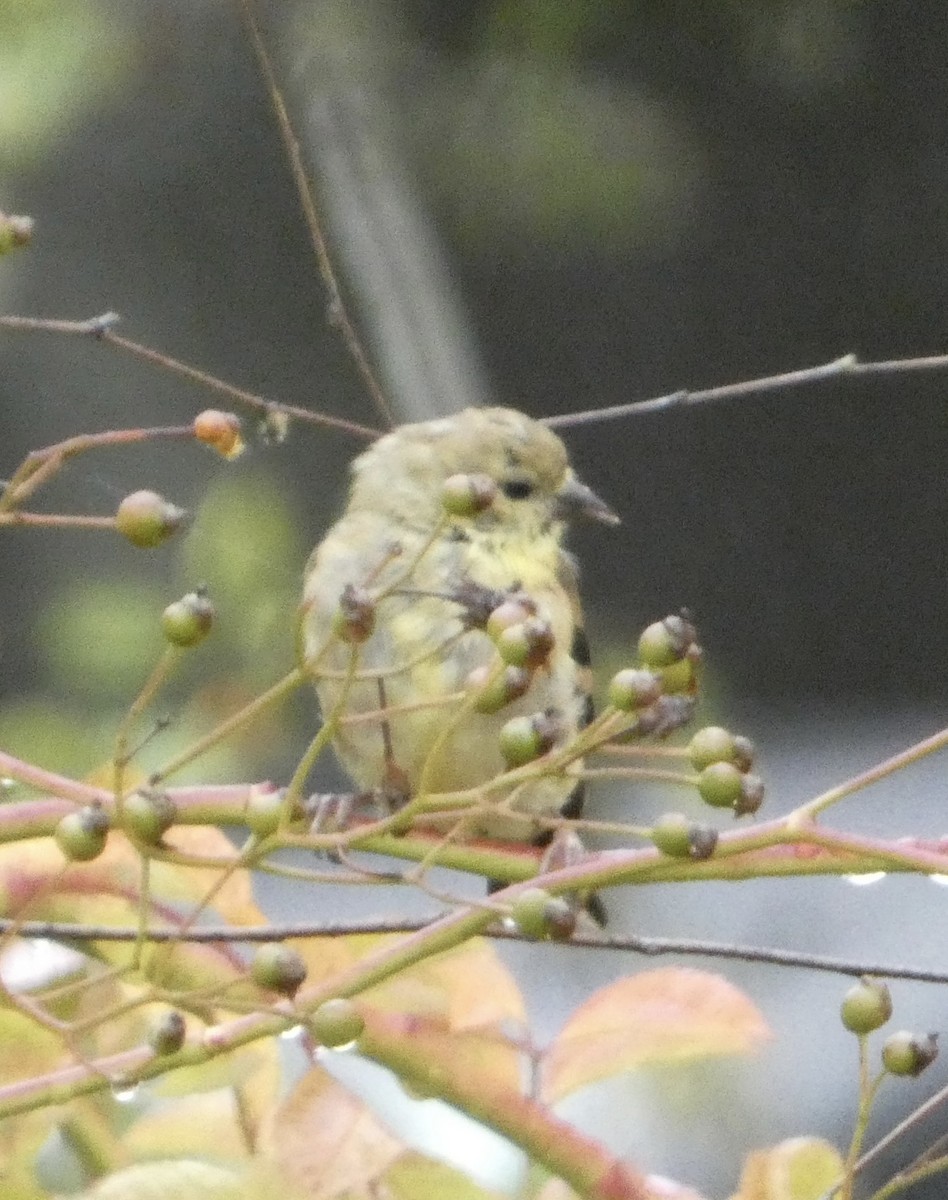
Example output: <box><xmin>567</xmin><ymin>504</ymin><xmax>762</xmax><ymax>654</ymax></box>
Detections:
<box><xmin>0</xmin><ymin>0</ymin><xmax>948</xmax><ymax>1195</ymax></box>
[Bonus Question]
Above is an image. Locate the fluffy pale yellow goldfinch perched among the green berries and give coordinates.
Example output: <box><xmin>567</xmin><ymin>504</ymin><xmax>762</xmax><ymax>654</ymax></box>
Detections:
<box><xmin>301</xmin><ymin>408</ymin><xmax>618</xmax><ymax>841</ymax></box>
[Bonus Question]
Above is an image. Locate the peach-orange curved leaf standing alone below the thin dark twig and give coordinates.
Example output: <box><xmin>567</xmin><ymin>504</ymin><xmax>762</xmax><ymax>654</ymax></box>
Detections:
<box><xmin>541</xmin><ymin>967</ymin><xmax>770</xmax><ymax>1104</ymax></box>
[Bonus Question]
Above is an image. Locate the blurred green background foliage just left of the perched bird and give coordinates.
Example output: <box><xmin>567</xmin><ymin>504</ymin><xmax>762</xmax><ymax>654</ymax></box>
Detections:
<box><xmin>0</xmin><ymin>467</ymin><xmax>305</xmax><ymax>782</ymax></box>
